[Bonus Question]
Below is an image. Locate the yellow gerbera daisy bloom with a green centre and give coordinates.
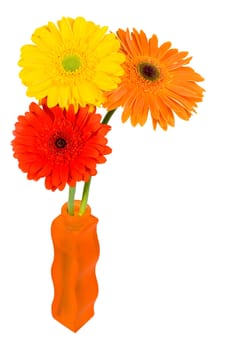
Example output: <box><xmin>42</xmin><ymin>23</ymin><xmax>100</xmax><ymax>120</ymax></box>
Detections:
<box><xmin>19</xmin><ymin>17</ymin><xmax>124</xmax><ymax>110</ymax></box>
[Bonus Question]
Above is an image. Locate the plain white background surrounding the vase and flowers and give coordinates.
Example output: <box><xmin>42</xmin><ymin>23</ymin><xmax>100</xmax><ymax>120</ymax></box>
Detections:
<box><xmin>0</xmin><ymin>0</ymin><xmax>233</xmax><ymax>350</ymax></box>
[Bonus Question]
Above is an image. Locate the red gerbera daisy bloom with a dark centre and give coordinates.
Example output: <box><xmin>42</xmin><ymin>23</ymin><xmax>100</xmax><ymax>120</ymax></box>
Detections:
<box><xmin>12</xmin><ymin>102</ymin><xmax>111</xmax><ymax>191</ymax></box>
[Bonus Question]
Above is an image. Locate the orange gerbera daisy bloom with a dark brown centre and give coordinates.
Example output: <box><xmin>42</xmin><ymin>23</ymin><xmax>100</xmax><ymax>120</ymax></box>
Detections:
<box><xmin>105</xmin><ymin>29</ymin><xmax>204</xmax><ymax>130</ymax></box>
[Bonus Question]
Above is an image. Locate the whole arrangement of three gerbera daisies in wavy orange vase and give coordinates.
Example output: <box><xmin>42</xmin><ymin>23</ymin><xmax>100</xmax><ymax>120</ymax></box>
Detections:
<box><xmin>12</xmin><ymin>17</ymin><xmax>204</xmax><ymax>332</ymax></box>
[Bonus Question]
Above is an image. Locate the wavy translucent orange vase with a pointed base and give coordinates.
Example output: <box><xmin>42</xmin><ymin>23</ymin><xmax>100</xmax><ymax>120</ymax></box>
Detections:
<box><xmin>51</xmin><ymin>201</ymin><xmax>99</xmax><ymax>332</ymax></box>
